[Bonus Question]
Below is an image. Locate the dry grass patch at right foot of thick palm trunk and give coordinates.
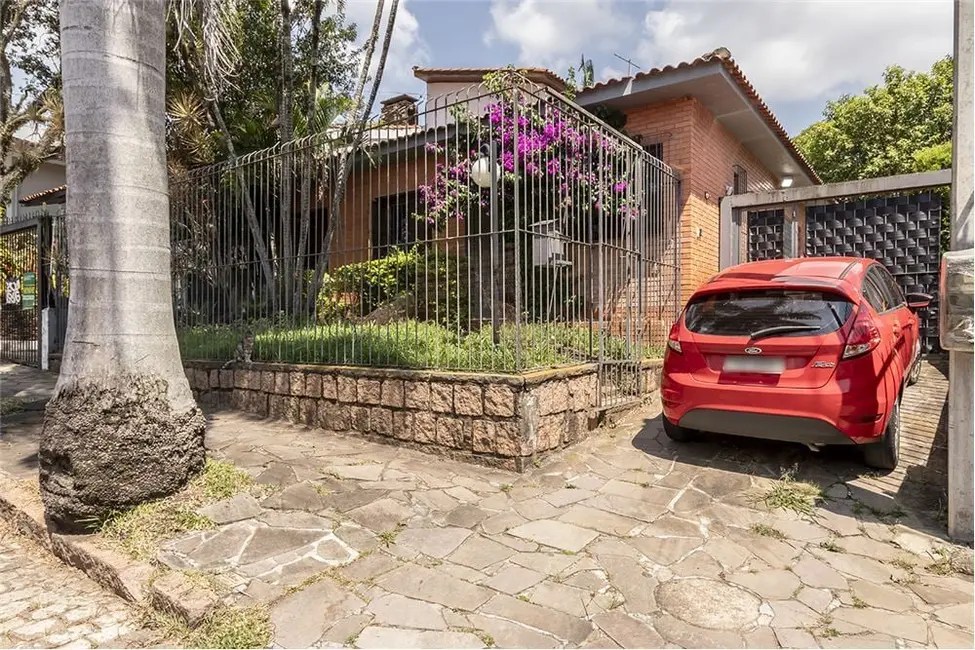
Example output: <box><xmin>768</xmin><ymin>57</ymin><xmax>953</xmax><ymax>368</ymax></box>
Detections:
<box><xmin>95</xmin><ymin>458</ymin><xmax>253</xmax><ymax>560</ymax></box>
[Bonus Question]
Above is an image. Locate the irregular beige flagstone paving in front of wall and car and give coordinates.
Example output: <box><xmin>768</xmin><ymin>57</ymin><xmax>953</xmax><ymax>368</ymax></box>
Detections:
<box><xmin>3</xmin><ymin>362</ymin><xmax>973</xmax><ymax>648</ymax></box>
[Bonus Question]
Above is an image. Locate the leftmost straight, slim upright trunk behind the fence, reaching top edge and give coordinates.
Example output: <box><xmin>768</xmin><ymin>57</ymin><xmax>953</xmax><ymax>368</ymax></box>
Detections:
<box><xmin>278</xmin><ymin>0</ymin><xmax>295</xmax><ymax>314</ymax></box>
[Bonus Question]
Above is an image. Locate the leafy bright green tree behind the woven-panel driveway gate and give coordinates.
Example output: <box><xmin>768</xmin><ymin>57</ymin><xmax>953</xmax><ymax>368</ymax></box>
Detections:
<box><xmin>795</xmin><ymin>57</ymin><xmax>953</xmax><ymax>182</ymax></box>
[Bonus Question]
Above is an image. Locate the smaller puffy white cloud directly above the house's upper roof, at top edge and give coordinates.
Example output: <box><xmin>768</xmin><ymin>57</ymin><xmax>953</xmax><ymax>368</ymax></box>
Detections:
<box><xmin>484</xmin><ymin>0</ymin><xmax>632</xmax><ymax>71</ymax></box>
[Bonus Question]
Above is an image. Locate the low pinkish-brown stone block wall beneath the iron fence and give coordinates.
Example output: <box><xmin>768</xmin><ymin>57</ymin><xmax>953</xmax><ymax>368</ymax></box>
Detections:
<box><xmin>184</xmin><ymin>361</ymin><xmax>661</xmax><ymax>471</ymax></box>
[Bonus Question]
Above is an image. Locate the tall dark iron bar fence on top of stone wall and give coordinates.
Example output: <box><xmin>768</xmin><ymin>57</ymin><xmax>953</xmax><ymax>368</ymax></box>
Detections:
<box><xmin>170</xmin><ymin>74</ymin><xmax>680</xmax><ymax>374</ymax></box>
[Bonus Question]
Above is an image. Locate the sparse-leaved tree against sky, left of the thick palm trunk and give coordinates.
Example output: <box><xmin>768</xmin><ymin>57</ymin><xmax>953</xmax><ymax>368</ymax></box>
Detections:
<box><xmin>0</xmin><ymin>0</ymin><xmax>63</xmax><ymax>206</ymax></box>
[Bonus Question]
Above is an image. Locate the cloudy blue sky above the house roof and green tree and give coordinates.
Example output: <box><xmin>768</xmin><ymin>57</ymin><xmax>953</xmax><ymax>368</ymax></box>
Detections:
<box><xmin>347</xmin><ymin>0</ymin><xmax>952</xmax><ymax>135</ymax></box>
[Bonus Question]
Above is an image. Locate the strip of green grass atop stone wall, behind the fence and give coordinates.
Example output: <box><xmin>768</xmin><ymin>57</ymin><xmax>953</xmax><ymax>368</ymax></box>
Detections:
<box><xmin>177</xmin><ymin>320</ymin><xmax>663</xmax><ymax>372</ymax></box>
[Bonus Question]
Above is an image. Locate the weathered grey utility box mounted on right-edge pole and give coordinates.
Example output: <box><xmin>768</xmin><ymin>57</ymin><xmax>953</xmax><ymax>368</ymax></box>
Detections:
<box><xmin>938</xmin><ymin>248</ymin><xmax>975</xmax><ymax>353</ymax></box>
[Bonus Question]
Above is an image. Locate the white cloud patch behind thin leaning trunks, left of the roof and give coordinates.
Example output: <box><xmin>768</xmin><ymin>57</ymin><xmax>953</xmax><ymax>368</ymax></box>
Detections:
<box><xmin>345</xmin><ymin>0</ymin><xmax>430</xmax><ymax>100</ymax></box>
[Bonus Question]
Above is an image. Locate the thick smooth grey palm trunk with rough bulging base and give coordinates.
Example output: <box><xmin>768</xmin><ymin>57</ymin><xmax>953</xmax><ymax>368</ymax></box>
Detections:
<box><xmin>40</xmin><ymin>0</ymin><xmax>205</xmax><ymax>530</ymax></box>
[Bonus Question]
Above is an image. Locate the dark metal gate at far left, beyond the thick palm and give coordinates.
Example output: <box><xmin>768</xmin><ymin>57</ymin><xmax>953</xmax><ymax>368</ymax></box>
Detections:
<box><xmin>0</xmin><ymin>213</ymin><xmax>68</xmax><ymax>367</ymax></box>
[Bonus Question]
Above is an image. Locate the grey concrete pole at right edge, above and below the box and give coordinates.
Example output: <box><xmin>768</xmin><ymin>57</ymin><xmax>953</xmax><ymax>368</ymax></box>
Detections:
<box><xmin>948</xmin><ymin>0</ymin><xmax>975</xmax><ymax>542</ymax></box>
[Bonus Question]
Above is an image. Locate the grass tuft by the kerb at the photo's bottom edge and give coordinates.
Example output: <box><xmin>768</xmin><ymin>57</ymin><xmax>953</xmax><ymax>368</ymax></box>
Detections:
<box><xmin>142</xmin><ymin>607</ymin><xmax>271</xmax><ymax>648</ymax></box>
